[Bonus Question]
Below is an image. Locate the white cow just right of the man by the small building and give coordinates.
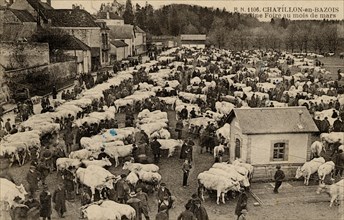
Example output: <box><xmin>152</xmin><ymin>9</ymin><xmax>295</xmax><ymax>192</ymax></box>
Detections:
<box><xmin>295</xmin><ymin>157</ymin><xmax>325</xmax><ymax>185</ymax></box>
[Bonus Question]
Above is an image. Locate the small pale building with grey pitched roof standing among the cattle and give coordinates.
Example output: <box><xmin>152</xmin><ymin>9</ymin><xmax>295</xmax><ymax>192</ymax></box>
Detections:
<box><xmin>227</xmin><ymin>107</ymin><xmax>318</xmax><ymax>179</ymax></box>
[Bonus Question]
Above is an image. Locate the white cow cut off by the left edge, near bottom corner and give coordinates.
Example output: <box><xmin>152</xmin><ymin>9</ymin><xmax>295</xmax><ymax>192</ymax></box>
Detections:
<box><xmin>0</xmin><ymin>178</ymin><xmax>27</xmax><ymax>210</ymax></box>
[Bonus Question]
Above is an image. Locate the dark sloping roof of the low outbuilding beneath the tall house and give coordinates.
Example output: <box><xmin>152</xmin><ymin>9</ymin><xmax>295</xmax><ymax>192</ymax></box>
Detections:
<box><xmin>40</xmin><ymin>35</ymin><xmax>91</xmax><ymax>51</ymax></box>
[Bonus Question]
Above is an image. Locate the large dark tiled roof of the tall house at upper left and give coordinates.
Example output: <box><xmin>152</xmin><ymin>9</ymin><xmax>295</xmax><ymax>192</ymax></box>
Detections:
<box><xmin>45</xmin><ymin>9</ymin><xmax>99</xmax><ymax>27</ymax></box>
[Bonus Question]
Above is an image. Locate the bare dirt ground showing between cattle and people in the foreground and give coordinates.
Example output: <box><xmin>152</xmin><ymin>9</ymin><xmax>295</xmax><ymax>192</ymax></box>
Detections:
<box><xmin>0</xmin><ymin>112</ymin><xmax>344</xmax><ymax>220</ymax></box>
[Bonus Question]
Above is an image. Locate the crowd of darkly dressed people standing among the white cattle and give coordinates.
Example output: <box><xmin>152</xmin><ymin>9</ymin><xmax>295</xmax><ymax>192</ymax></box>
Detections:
<box><xmin>0</xmin><ymin>45</ymin><xmax>344</xmax><ymax>220</ymax></box>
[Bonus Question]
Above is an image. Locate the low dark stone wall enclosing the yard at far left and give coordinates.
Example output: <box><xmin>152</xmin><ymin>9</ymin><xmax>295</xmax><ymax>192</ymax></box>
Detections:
<box><xmin>5</xmin><ymin>61</ymin><xmax>77</xmax><ymax>96</ymax></box>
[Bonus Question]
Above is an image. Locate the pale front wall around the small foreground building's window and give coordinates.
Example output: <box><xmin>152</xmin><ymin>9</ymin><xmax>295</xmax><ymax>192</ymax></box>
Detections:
<box><xmin>248</xmin><ymin>133</ymin><xmax>308</xmax><ymax>165</ymax></box>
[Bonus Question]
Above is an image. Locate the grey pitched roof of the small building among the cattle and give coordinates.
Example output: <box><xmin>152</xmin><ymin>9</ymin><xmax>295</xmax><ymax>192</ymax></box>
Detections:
<box><xmin>227</xmin><ymin>106</ymin><xmax>319</xmax><ymax>134</ymax></box>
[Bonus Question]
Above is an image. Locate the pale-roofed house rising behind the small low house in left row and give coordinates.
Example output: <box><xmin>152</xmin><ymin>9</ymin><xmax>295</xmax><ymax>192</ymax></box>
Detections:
<box><xmin>108</xmin><ymin>24</ymin><xmax>135</xmax><ymax>58</ymax></box>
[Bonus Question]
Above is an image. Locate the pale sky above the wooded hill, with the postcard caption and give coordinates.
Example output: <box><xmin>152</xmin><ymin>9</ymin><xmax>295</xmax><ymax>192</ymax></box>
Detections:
<box><xmin>51</xmin><ymin>0</ymin><xmax>344</xmax><ymax>21</ymax></box>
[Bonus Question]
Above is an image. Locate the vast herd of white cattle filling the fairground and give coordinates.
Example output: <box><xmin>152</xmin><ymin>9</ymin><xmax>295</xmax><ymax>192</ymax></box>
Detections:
<box><xmin>0</xmin><ymin>48</ymin><xmax>344</xmax><ymax>219</ymax></box>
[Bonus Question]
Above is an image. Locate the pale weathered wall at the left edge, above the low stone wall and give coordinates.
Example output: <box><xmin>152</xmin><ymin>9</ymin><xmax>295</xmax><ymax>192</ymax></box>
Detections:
<box><xmin>0</xmin><ymin>42</ymin><xmax>49</xmax><ymax>69</ymax></box>
